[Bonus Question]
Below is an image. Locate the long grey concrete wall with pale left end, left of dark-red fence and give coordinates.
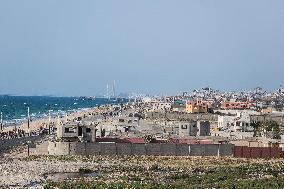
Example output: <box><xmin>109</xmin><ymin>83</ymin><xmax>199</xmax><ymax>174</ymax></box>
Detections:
<box><xmin>41</xmin><ymin>142</ymin><xmax>234</xmax><ymax>156</ymax></box>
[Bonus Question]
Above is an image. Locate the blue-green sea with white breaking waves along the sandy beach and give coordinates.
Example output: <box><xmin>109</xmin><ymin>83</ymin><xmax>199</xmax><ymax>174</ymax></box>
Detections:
<box><xmin>0</xmin><ymin>95</ymin><xmax>125</xmax><ymax>125</ymax></box>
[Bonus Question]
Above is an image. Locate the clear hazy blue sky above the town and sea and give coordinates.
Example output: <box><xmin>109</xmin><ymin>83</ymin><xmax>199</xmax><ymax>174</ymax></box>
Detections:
<box><xmin>0</xmin><ymin>0</ymin><xmax>284</xmax><ymax>96</ymax></box>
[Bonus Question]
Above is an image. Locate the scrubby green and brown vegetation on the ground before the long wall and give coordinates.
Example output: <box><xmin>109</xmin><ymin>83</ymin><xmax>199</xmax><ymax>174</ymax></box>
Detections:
<box><xmin>41</xmin><ymin>156</ymin><xmax>284</xmax><ymax>189</ymax></box>
